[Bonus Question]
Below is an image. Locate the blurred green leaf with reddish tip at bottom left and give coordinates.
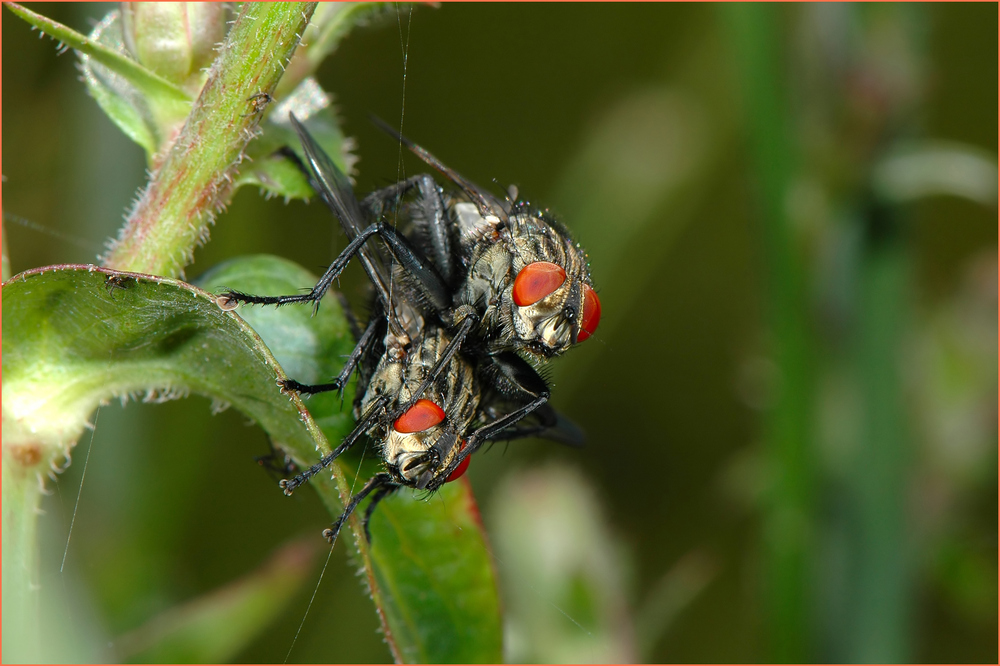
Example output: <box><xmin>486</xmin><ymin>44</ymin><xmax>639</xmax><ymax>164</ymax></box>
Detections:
<box><xmin>115</xmin><ymin>539</ymin><xmax>321</xmax><ymax>664</ymax></box>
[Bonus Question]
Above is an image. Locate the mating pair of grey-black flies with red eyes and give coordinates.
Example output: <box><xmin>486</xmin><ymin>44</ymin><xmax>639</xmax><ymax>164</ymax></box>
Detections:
<box><xmin>219</xmin><ymin>114</ymin><xmax>601</xmax><ymax>542</ymax></box>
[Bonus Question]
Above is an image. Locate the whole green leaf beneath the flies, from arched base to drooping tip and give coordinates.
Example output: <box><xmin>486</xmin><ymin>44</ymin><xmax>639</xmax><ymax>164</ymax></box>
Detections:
<box><xmin>3</xmin><ymin>257</ymin><xmax>501</xmax><ymax>662</ymax></box>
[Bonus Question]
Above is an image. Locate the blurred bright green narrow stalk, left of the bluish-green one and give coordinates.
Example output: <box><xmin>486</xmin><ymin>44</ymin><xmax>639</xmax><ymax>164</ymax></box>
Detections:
<box><xmin>724</xmin><ymin>4</ymin><xmax>816</xmax><ymax>662</ymax></box>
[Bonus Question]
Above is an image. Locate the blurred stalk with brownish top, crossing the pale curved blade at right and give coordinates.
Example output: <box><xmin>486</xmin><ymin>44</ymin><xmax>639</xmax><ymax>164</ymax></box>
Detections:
<box><xmin>824</xmin><ymin>6</ymin><xmax>924</xmax><ymax>662</ymax></box>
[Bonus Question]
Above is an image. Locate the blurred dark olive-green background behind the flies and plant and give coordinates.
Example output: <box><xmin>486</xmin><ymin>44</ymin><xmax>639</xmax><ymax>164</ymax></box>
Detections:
<box><xmin>2</xmin><ymin>3</ymin><xmax>998</xmax><ymax>663</ymax></box>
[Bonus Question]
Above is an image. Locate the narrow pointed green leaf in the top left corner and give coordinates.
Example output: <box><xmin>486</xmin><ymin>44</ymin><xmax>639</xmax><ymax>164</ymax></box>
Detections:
<box><xmin>4</xmin><ymin>2</ymin><xmax>191</xmax><ymax>102</ymax></box>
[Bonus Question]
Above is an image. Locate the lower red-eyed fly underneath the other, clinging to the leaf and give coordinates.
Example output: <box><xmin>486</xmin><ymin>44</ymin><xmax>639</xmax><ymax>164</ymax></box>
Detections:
<box><xmin>256</xmin><ymin>117</ymin><xmax>582</xmax><ymax>541</ymax></box>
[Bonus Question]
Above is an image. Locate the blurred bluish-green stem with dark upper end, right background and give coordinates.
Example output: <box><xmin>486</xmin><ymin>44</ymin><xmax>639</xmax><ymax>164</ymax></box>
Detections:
<box><xmin>842</xmin><ymin>209</ymin><xmax>912</xmax><ymax>663</ymax></box>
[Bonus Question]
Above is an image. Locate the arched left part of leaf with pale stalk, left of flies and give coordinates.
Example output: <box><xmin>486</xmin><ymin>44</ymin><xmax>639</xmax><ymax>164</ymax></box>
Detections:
<box><xmin>2</xmin><ymin>266</ymin><xmax>344</xmax><ymax>661</ymax></box>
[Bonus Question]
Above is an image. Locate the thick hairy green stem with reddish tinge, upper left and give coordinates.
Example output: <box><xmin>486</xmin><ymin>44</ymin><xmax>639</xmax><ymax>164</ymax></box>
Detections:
<box><xmin>103</xmin><ymin>2</ymin><xmax>315</xmax><ymax>277</ymax></box>
